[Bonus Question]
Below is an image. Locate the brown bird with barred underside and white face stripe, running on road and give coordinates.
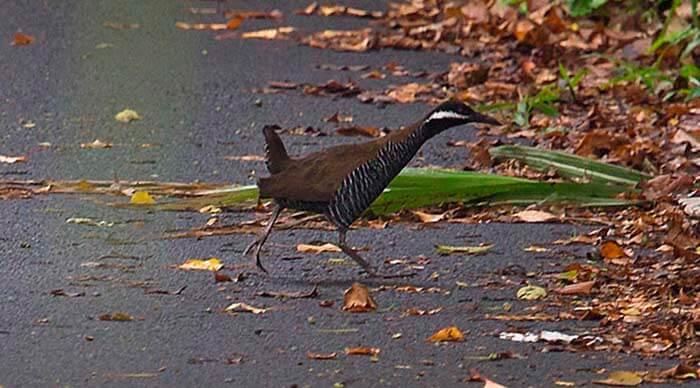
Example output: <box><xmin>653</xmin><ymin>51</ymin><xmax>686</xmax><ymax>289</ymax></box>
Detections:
<box><xmin>243</xmin><ymin>100</ymin><xmax>500</xmax><ymax>277</ymax></box>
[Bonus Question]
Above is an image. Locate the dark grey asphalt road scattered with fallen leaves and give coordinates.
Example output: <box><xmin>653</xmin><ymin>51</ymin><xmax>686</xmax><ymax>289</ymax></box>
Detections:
<box><xmin>0</xmin><ymin>0</ymin><xmax>671</xmax><ymax>387</ymax></box>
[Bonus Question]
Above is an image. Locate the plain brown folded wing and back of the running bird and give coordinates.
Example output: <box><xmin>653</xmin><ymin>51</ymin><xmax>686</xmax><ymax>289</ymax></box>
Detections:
<box><xmin>258</xmin><ymin>138</ymin><xmax>386</xmax><ymax>202</ymax></box>
